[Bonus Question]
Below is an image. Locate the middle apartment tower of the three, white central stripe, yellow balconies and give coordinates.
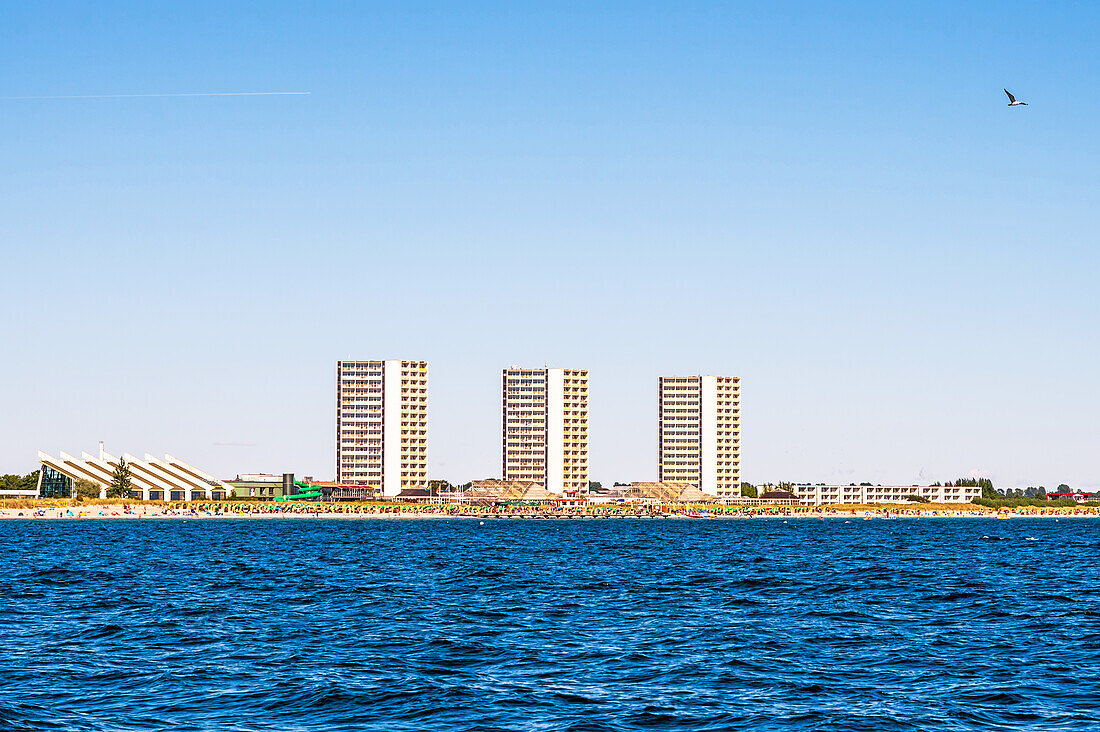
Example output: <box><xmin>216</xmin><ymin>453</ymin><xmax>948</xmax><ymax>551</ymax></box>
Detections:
<box><xmin>501</xmin><ymin>367</ymin><xmax>589</xmax><ymax>495</ymax></box>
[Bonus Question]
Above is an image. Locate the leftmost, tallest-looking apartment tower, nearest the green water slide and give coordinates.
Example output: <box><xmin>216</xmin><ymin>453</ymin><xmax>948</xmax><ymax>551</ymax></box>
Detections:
<box><xmin>337</xmin><ymin>361</ymin><xmax>428</xmax><ymax>498</ymax></box>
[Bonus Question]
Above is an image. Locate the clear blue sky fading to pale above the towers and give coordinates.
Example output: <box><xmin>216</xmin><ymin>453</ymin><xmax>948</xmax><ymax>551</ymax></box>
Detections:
<box><xmin>0</xmin><ymin>5</ymin><xmax>1100</xmax><ymax>488</ymax></box>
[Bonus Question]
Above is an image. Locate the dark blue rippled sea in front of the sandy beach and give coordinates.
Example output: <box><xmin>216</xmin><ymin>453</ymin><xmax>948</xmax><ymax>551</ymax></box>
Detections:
<box><xmin>0</xmin><ymin>518</ymin><xmax>1100</xmax><ymax>732</ymax></box>
